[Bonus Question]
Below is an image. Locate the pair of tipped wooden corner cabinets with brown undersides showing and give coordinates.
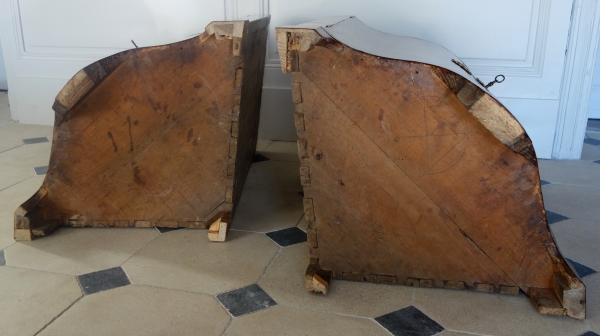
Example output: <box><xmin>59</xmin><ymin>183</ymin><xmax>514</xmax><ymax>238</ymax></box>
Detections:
<box><xmin>15</xmin><ymin>17</ymin><xmax>585</xmax><ymax>318</ymax></box>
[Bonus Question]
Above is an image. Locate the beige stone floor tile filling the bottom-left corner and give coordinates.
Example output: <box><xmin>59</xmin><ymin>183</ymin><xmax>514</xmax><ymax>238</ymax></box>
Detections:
<box><xmin>0</xmin><ymin>266</ymin><xmax>83</xmax><ymax>336</ymax></box>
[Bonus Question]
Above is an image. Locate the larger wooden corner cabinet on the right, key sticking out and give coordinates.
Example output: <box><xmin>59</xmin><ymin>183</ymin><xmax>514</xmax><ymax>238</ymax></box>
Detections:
<box><xmin>276</xmin><ymin>17</ymin><xmax>585</xmax><ymax>319</ymax></box>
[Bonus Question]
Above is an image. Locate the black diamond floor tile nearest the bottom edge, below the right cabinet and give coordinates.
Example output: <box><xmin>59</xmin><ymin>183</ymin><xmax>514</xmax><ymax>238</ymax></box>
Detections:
<box><xmin>375</xmin><ymin>306</ymin><xmax>444</xmax><ymax>336</ymax></box>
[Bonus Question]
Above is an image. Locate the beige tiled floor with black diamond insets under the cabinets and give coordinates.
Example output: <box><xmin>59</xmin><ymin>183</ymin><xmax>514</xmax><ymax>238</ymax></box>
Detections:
<box><xmin>0</xmin><ymin>93</ymin><xmax>600</xmax><ymax>336</ymax></box>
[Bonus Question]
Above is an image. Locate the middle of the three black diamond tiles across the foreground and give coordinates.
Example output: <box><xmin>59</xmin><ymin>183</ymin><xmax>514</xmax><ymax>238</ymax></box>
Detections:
<box><xmin>217</xmin><ymin>284</ymin><xmax>277</xmax><ymax>317</ymax></box>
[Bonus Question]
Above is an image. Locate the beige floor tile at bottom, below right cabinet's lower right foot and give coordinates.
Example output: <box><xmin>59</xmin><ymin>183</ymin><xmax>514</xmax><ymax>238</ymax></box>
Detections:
<box><xmin>414</xmin><ymin>288</ymin><xmax>587</xmax><ymax>336</ymax></box>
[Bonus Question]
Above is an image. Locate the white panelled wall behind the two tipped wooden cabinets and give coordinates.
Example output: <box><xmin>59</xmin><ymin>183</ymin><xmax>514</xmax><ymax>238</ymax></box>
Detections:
<box><xmin>0</xmin><ymin>0</ymin><xmax>572</xmax><ymax>158</ymax></box>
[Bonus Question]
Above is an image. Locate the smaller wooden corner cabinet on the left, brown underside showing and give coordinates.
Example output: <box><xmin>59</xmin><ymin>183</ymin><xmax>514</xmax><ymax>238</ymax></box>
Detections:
<box><xmin>15</xmin><ymin>17</ymin><xmax>270</xmax><ymax>240</ymax></box>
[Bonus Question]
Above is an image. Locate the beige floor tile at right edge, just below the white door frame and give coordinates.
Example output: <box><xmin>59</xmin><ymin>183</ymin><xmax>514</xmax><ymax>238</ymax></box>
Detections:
<box><xmin>538</xmin><ymin>160</ymin><xmax>600</xmax><ymax>187</ymax></box>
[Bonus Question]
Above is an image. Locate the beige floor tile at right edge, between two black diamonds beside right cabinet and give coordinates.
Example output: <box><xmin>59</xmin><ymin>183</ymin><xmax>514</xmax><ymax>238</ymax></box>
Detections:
<box><xmin>550</xmin><ymin>218</ymin><xmax>600</xmax><ymax>270</ymax></box>
